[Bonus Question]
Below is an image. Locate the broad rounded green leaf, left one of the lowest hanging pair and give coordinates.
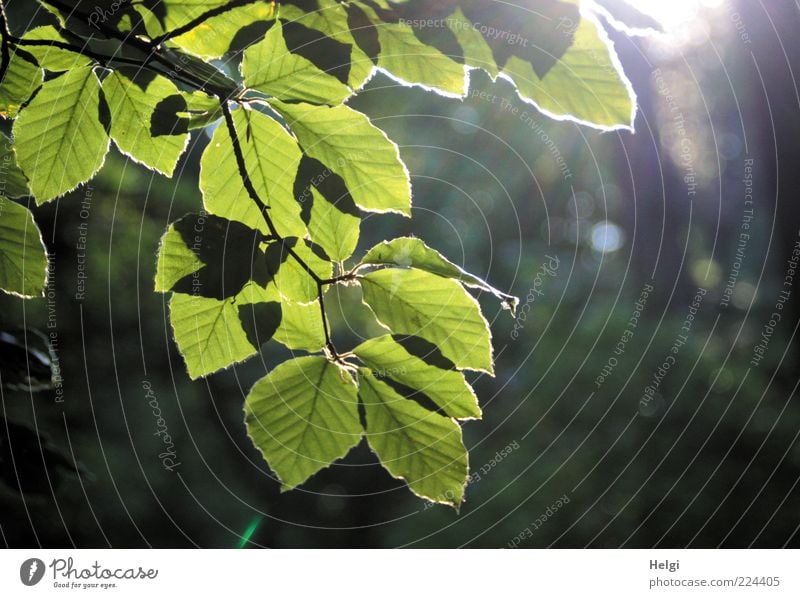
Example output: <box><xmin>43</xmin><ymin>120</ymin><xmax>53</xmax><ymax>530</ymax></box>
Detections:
<box><xmin>245</xmin><ymin>357</ymin><xmax>362</xmax><ymax>490</ymax></box>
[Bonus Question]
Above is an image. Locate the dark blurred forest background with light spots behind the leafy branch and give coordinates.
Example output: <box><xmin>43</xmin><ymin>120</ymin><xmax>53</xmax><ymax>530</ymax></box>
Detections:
<box><xmin>0</xmin><ymin>0</ymin><xmax>800</xmax><ymax>548</ymax></box>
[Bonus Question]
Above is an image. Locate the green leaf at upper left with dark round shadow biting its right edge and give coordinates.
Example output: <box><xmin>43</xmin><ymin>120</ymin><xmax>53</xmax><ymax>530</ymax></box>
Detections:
<box><xmin>103</xmin><ymin>70</ymin><xmax>189</xmax><ymax>176</ymax></box>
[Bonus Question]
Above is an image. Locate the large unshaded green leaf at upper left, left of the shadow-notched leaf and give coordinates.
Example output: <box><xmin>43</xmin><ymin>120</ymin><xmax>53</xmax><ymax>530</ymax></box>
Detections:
<box><xmin>14</xmin><ymin>67</ymin><xmax>109</xmax><ymax>204</ymax></box>
